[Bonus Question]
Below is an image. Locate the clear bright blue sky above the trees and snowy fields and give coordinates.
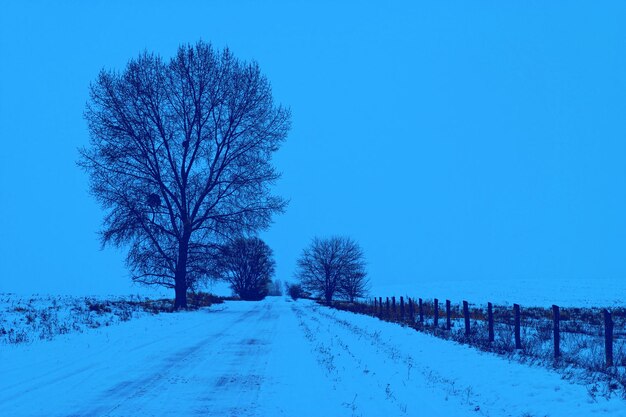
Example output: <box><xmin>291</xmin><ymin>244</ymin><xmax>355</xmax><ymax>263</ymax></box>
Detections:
<box><xmin>0</xmin><ymin>1</ymin><xmax>626</xmax><ymax>294</ymax></box>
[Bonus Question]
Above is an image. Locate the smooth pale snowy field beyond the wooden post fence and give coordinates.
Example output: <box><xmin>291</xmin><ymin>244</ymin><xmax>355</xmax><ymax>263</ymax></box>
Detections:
<box><xmin>372</xmin><ymin>278</ymin><xmax>626</xmax><ymax>307</ymax></box>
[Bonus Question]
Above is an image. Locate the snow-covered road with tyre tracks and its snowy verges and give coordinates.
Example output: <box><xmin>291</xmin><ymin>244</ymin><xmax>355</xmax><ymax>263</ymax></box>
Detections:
<box><xmin>0</xmin><ymin>298</ymin><xmax>626</xmax><ymax>417</ymax></box>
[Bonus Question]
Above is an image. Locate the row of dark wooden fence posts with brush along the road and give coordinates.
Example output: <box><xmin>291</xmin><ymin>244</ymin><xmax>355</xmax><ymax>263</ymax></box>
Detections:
<box><xmin>326</xmin><ymin>297</ymin><xmax>626</xmax><ymax>387</ymax></box>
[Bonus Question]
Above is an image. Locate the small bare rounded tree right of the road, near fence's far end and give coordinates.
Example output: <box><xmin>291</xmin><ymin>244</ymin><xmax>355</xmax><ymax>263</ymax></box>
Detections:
<box><xmin>296</xmin><ymin>236</ymin><xmax>366</xmax><ymax>303</ymax></box>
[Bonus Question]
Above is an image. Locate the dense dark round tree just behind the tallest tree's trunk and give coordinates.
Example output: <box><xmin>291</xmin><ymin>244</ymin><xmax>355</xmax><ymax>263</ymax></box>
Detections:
<box><xmin>219</xmin><ymin>237</ymin><xmax>280</xmax><ymax>300</ymax></box>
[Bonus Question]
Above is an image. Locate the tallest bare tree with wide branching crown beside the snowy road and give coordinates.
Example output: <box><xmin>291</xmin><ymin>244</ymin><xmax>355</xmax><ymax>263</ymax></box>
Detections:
<box><xmin>79</xmin><ymin>42</ymin><xmax>290</xmax><ymax>308</ymax></box>
